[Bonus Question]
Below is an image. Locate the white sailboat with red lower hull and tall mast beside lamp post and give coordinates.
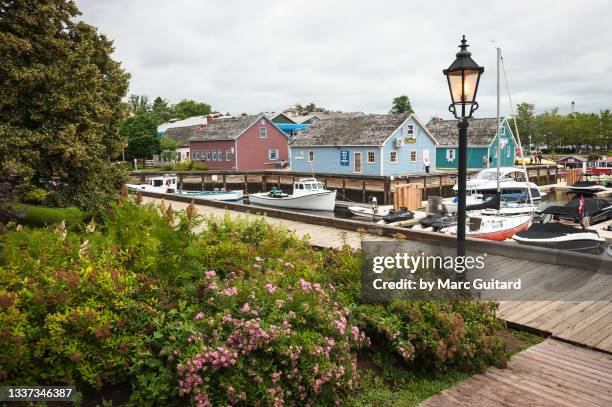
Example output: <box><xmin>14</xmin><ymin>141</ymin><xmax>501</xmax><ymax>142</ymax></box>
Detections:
<box><xmin>434</xmin><ymin>47</ymin><xmax>536</xmax><ymax>240</ymax></box>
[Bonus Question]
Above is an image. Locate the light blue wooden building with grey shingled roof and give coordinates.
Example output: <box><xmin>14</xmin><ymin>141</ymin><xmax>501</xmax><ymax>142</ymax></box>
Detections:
<box><xmin>289</xmin><ymin>114</ymin><xmax>437</xmax><ymax>175</ymax></box>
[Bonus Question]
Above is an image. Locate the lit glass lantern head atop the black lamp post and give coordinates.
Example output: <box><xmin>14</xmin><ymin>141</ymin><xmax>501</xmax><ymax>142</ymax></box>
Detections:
<box><xmin>442</xmin><ymin>35</ymin><xmax>484</xmax><ymax>119</ymax></box>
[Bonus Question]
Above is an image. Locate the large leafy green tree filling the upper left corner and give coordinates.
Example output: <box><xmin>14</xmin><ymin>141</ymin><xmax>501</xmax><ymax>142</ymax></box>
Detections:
<box><xmin>0</xmin><ymin>0</ymin><xmax>129</xmax><ymax>207</ymax></box>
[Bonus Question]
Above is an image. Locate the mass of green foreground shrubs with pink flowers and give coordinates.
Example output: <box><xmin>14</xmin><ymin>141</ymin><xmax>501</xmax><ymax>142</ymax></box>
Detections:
<box><xmin>0</xmin><ymin>200</ymin><xmax>505</xmax><ymax>405</ymax></box>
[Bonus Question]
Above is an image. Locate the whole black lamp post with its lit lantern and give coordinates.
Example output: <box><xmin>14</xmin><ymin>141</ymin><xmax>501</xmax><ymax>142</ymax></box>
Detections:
<box><xmin>442</xmin><ymin>35</ymin><xmax>484</xmax><ymax>257</ymax></box>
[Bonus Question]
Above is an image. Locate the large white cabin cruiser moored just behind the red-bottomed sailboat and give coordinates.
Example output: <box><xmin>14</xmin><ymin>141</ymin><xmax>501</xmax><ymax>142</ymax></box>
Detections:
<box><xmin>453</xmin><ymin>167</ymin><xmax>542</xmax><ymax>201</ymax></box>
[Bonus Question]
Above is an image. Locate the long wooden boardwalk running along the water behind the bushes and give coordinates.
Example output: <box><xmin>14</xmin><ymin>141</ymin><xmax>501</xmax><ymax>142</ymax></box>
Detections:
<box><xmin>144</xmin><ymin>197</ymin><xmax>612</xmax><ymax>353</ymax></box>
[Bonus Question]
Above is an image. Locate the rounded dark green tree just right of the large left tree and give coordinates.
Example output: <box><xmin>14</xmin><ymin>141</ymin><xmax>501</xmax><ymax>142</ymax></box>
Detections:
<box><xmin>119</xmin><ymin>112</ymin><xmax>161</xmax><ymax>161</ymax></box>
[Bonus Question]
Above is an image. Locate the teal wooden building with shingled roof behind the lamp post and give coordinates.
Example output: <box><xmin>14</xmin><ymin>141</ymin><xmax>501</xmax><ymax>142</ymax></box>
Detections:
<box><xmin>427</xmin><ymin>118</ymin><xmax>517</xmax><ymax>170</ymax></box>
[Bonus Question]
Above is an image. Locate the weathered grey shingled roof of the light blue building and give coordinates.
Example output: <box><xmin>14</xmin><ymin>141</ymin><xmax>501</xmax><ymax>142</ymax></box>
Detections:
<box><xmin>291</xmin><ymin>114</ymin><xmax>408</xmax><ymax>146</ymax></box>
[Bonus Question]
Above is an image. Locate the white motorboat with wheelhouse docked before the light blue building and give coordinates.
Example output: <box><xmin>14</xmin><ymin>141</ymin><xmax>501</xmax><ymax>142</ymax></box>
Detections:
<box><xmin>249</xmin><ymin>178</ymin><xmax>336</xmax><ymax>212</ymax></box>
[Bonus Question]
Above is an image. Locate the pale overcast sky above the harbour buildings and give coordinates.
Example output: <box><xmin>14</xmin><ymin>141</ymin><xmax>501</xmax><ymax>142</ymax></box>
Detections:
<box><xmin>77</xmin><ymin>0</ymin><xmax>612</xmax><ymax>120</ymax></box>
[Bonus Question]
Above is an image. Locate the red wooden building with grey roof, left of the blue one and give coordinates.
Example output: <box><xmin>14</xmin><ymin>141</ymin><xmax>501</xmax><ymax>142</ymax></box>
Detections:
<box><xmin>190</xmin><ymin>114</ymin><xmax>289</xmax><ymax>171</ymax></box>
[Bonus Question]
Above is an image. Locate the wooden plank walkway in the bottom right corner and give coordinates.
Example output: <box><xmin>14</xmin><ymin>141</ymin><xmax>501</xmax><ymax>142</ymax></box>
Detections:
<box><xmin>420</xmin><ymin>339</ymin><xmax>612</xmax><ymax>407</ymax></box>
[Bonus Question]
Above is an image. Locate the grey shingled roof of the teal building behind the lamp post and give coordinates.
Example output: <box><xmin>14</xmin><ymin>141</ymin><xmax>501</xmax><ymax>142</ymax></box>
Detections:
<box><xmin>427</xmin><ymin>117</ymin><xmax>497</xmax><ymax>147</ymax></box>
